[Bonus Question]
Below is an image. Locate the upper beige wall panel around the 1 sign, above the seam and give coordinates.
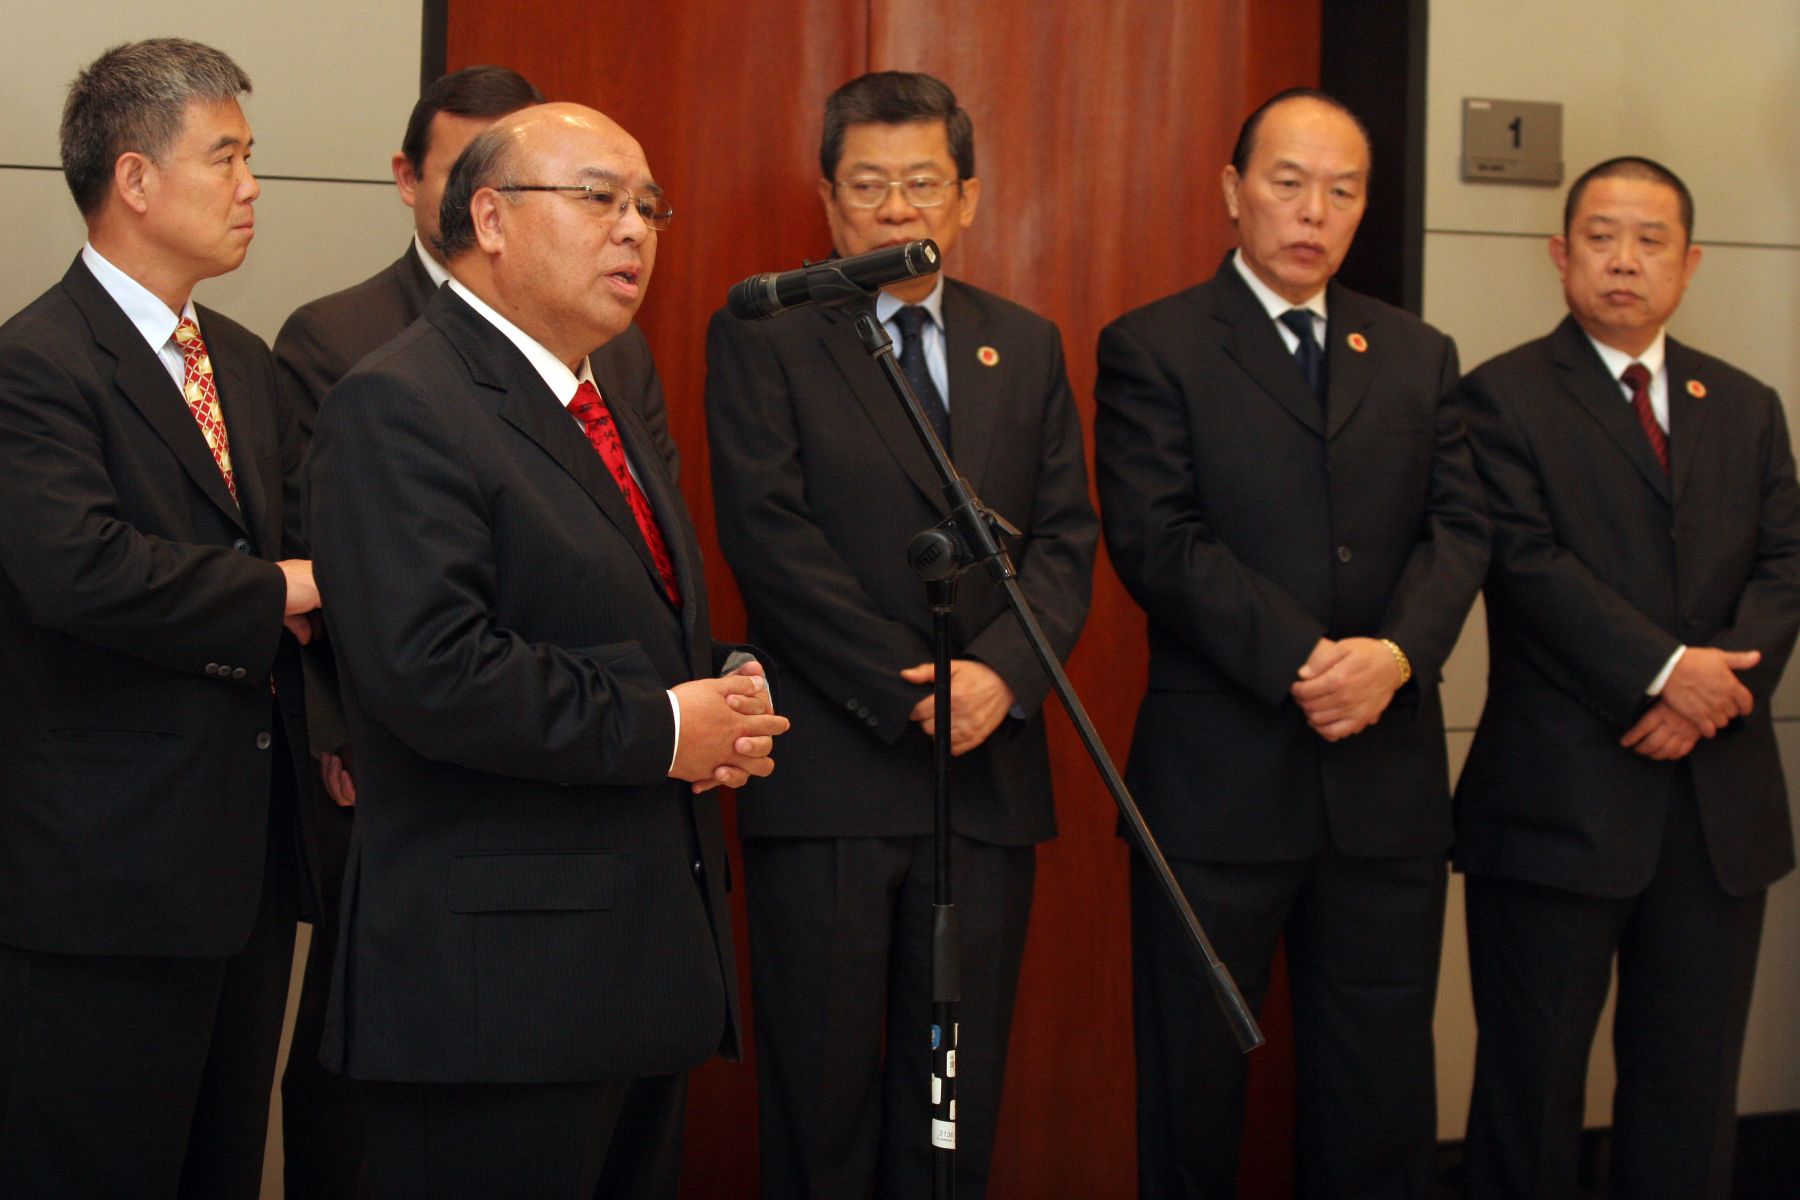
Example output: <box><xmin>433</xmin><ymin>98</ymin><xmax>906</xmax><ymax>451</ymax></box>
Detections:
<box><xmin>1426</xmin><ymin>0</ymin><xmax>1800</xmax><ymax>245</ymax></box>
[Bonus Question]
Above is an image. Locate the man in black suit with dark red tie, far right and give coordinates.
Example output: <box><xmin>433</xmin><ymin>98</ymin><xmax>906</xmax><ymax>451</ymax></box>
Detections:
<box><xmin>1456</xmin><ymin>158</ymin><xmax>1800</xmax><ymax>1200</ymax></box>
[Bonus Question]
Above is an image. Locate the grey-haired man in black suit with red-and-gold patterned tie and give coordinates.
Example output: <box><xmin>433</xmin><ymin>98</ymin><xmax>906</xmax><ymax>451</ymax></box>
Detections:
<box><xmin>0</xmin><ymin>38</ymin><xmax>319</xmax><ymax>1198</ymax></box>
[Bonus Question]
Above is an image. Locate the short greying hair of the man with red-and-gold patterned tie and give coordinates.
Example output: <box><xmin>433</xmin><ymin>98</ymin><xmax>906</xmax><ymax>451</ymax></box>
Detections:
<box><xmin>59</xmin><ymin>38</ymin><xmax>250</xmax><ymax>216</ymax></box>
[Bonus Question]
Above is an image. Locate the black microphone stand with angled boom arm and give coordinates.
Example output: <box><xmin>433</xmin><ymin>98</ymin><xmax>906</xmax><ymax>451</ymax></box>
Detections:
<box><xmin>853</xmin><ymin>307</ymin><xmax>1264</xmax><ymax>1200</ymax></box>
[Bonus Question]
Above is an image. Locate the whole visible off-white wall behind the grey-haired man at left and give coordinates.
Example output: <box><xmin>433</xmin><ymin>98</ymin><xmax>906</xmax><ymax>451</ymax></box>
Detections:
<box><xmin>0</xmin><ymin>0</ymin><xmax>421</xmax><ymax>338</ymax></box>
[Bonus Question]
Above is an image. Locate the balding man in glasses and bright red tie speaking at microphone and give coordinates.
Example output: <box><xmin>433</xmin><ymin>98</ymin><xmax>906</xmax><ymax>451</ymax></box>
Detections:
<box><xmin>311</xmin><ymin>104</ymin><xmax>787</xmax><ymax>1196</ymax></box>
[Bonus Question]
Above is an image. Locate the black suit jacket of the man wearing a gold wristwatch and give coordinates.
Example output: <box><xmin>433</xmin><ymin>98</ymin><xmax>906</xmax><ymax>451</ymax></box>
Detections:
<box><xmin>1094</xmin><ymin>259</ymin><xmax>1487</xmax><ymax>862</ymax></box>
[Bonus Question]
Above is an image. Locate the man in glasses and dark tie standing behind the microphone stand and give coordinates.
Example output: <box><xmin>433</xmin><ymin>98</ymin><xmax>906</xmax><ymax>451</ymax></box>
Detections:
<box><xmin>706</xmin><ymin>72</ymin><xmax>1098</xmax><ymax>1196</ymax></box>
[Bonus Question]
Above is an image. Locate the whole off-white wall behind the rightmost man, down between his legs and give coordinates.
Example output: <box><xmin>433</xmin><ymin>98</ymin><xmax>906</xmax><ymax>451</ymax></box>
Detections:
<box><xmin>1424</xmin><ymin>0</ymin><xmax>1800</xmax><ymax>1139</ymax></box>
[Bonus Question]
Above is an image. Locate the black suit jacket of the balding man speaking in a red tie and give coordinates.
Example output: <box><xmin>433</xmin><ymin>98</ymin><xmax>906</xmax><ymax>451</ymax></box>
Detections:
<box><xmin>311</xmin><ymin>288</ymin><xmax>736</xmax><ymax>1083</ymax></box>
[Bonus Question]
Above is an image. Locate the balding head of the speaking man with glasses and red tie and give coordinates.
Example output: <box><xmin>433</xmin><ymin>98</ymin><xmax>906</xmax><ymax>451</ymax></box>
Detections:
<box><xmin>439</xmin><ymin>104</ymin><xmax>664</xmax><ymax>365</ymax></box>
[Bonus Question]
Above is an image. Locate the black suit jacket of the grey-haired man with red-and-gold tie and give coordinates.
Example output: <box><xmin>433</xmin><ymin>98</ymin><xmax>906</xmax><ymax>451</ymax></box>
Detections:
<box><xmin>0</xmin><ymin>259</ymin><xmax>304</xmax><ymax>957</ymax></box>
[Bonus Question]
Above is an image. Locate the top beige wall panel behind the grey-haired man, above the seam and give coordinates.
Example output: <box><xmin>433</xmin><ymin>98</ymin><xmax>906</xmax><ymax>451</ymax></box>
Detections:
<box><xmin>0</xmin><ymin>0</ymin><xmax>421</xmax><ymax>180</ymax></box>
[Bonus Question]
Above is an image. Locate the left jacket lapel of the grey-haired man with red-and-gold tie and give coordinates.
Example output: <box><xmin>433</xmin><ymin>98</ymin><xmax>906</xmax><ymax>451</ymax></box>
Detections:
<box><xmin>63</xmin><ymin>257</ymin><xmax>250</xmax><ymax>533</ymax></box>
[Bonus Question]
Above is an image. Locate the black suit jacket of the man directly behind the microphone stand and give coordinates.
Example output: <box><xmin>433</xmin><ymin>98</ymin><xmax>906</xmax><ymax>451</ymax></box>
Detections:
<box><xmin>706</xmin><ymin>279</ymin><xmax>1098</xmax><ymax>846</ymax></box>
